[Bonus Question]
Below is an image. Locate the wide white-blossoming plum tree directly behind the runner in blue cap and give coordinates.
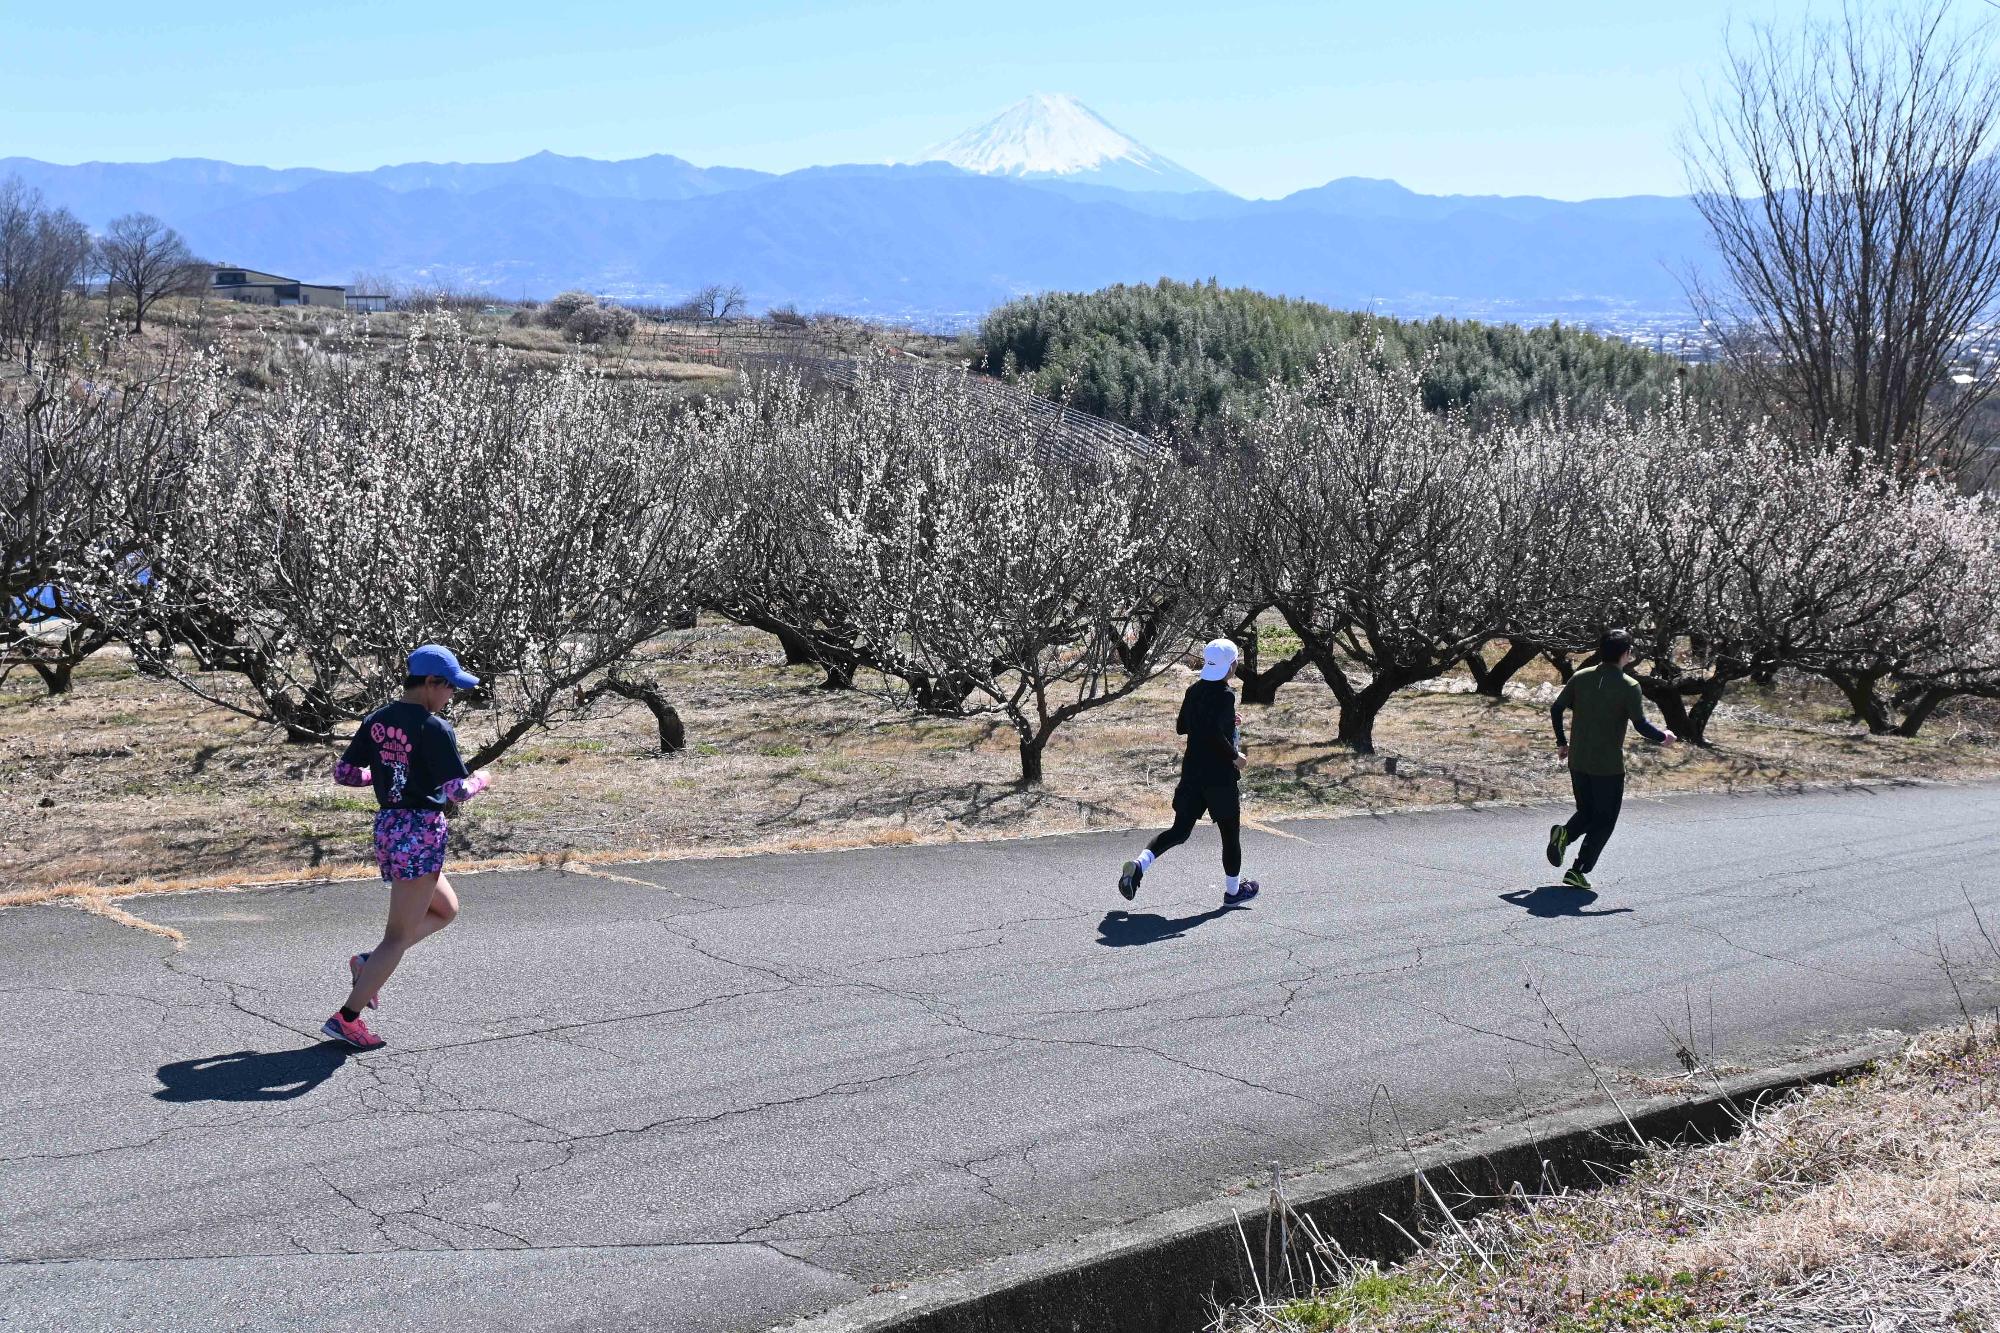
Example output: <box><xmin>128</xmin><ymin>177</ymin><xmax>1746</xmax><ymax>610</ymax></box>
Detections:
<box><xmin>68</xmin><ymin>316</ymin><xmax>732</xmax><ymax>763</ymax></box>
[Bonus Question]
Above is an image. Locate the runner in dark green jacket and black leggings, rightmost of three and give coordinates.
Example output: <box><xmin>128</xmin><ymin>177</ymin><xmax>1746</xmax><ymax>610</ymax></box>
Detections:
<box><xmin>1548</xmin><ymin>630</ymin><xmax>1678</xmax><ymax>889</ymax></box>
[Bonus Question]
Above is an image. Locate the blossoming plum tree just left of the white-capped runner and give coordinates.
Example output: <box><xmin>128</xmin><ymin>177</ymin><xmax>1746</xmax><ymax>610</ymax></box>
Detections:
<box><xmin>842</xmin><ymin>372</ymin><xmax>1202</xmax><ymax>787</ymax></box>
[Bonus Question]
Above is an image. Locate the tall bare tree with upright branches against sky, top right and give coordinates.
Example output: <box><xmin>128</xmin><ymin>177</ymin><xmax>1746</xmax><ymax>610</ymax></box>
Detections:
<box><xmin>1682</xmin><ymin>0</ymin><xmax>2000</xmax><ymax>476</ymax></box>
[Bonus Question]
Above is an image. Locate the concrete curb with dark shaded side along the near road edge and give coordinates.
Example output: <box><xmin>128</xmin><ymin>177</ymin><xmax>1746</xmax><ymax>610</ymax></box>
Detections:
<box><xmin>784</xmin><ymin>1037</ymin><xmax>1906</xmax><ymax>1333</ymax></box>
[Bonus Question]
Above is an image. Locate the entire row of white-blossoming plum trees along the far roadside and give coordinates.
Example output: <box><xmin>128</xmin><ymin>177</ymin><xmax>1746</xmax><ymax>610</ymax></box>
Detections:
<box><xmin>15</xmin><ymin>316</ymin><xmax>2000</xmax><ymax>783</ymax></box>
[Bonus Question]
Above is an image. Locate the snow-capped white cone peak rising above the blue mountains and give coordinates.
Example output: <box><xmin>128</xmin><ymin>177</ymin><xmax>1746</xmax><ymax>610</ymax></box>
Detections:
<box><xmin>918</xmin><ymin>92</ymin><xmax>1220</xmax><ymax>194</ymax></box>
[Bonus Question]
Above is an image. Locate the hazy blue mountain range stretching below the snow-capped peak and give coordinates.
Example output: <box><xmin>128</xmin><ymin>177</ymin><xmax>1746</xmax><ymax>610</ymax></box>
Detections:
<box><xmin>0</xmin><ymin>99</ymin><xmax>1708</xmax><ymax>326</ymax></box>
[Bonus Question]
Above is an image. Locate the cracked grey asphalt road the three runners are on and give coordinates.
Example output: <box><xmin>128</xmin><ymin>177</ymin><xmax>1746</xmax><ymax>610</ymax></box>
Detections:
<box><xmin>0</xmin><ymin>787</ymin><xmax>2000</xmax><ymax>1331</ymax></box>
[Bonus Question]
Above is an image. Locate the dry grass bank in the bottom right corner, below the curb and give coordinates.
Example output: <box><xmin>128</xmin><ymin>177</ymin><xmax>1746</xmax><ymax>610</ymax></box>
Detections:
<box><xmin>1220</xmin><ymin>1025</ymin><xmax>2000</xmax><ymax>1333</ymax></box>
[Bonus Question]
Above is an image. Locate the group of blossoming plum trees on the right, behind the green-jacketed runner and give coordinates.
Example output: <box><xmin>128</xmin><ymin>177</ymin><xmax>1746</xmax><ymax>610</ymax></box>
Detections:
<box><xmin>1212</xmin><ymin>348</ymin><xmax>2000</xmax><ymax>751</ymax></box>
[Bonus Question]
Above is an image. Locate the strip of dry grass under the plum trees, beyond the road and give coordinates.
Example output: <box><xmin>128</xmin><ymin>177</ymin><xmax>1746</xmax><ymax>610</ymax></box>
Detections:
<box><xmin>0</xmin><ymin>626</ymin><xmax>2000</xmax><ymax>907</ymax></box>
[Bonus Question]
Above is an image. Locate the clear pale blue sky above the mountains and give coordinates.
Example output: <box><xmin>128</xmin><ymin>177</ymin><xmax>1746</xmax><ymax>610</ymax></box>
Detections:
<box><xmin>0</xmin><ymin>0</ymin><xmax>1896</xmax><ymax>198</ymax></box>
